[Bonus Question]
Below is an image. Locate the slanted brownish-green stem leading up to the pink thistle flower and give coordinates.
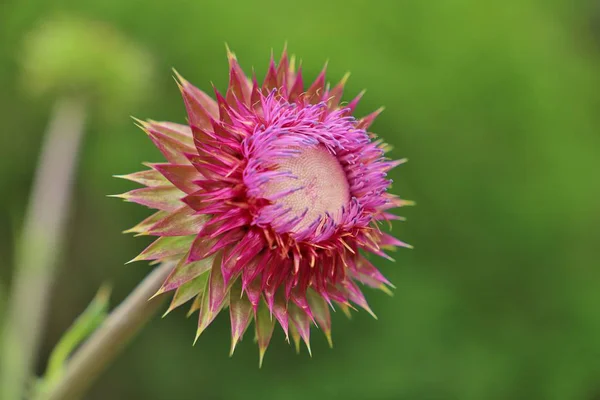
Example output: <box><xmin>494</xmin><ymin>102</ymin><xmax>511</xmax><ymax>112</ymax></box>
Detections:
<box><xmin>41</xmin><ymin>262</ymin><xmax>175</xmax><ymax>400</ymax></box>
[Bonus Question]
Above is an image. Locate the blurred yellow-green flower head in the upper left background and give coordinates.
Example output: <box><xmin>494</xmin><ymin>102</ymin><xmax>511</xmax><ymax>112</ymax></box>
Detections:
<box><xmin>22</xmin><ymin>15</ymin><xmax>152</xmax><ymax>112</ymax></box>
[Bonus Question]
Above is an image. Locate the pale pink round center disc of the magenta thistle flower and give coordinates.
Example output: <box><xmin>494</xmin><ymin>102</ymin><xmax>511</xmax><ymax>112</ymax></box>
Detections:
<box><xmin>265</xmin><ymin>145</ymin><xmax>350</xmax><ymax>233</ymax></box>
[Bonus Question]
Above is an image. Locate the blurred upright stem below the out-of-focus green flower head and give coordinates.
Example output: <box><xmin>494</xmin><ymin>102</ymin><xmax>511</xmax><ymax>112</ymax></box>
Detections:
<box><xmin>0</xmin><ymin>97</ymin><xmax>86</xmax><ymax>400</ymax></box>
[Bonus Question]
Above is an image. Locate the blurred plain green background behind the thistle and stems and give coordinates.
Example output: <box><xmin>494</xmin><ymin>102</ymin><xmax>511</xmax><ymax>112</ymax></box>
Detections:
<box><xmin>0</xmin><ymin>0</ymin><xmax>600</xmax><ymax>400</ymax></box>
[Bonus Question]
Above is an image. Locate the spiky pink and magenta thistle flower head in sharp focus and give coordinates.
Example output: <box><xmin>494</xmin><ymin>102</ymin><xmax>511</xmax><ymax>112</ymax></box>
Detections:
<box><xmin>119</xmin><ymin>49</ymin><xmax>409</xmax><ymax>363</ymax></box>
